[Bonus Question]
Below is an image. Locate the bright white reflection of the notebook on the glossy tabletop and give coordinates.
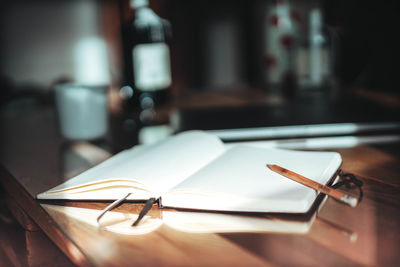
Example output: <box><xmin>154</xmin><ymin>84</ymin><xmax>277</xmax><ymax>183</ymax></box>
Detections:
<box><xmin>42</xmin><ymin>204</ymin><xmax>310</xmax><ymax>235</ymax></box>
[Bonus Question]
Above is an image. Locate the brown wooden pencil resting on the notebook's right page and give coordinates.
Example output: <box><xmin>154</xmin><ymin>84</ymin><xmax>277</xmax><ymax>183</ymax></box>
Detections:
<box><xmin>267</xmin><ymin>164</ymin><xmax>358</xmax><ymax>208</ymax></box>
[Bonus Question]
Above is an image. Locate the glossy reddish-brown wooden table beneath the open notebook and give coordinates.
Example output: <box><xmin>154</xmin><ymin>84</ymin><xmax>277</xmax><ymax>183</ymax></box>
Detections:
<box><xmin>0</xmin><ymin>103</ymin><xmax>400</xmax><ymax>266</ymax></box>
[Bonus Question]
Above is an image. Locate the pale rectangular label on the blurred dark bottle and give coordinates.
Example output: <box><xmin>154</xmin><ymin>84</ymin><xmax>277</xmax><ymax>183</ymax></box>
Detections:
<box><xmin>132</xmin><ymin>43</ymin><xmax>171</xmax><ymax>91</ymax></box>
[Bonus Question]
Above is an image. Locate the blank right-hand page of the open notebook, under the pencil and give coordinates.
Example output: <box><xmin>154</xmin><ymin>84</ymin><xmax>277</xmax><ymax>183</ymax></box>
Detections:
<box><xmin>162</xmin><ymin>146</ymin><xmax>341</xmax><ymax>213</ymax></box>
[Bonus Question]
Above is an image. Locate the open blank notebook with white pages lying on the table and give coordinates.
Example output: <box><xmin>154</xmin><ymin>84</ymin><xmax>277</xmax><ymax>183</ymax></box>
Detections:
<box><xmin>37</xmin><ymin>131</ymin><xmax>341</xmax><ymax>213</ymax></box>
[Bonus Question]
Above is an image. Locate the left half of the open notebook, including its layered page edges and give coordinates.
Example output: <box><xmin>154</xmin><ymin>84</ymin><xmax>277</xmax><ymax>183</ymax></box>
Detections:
<box><xmin>37</xmin><ymin>131</ymin><xmax>225</xmax><ymax>200</ymax></box>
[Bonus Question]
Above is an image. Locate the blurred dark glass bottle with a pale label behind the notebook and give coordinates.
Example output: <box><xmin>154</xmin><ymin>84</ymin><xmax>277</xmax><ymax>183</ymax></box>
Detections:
<box><xmin>121</xmin><ymin>0</ymin><xmax>172</xmax><ymax>126</ymax></box>
